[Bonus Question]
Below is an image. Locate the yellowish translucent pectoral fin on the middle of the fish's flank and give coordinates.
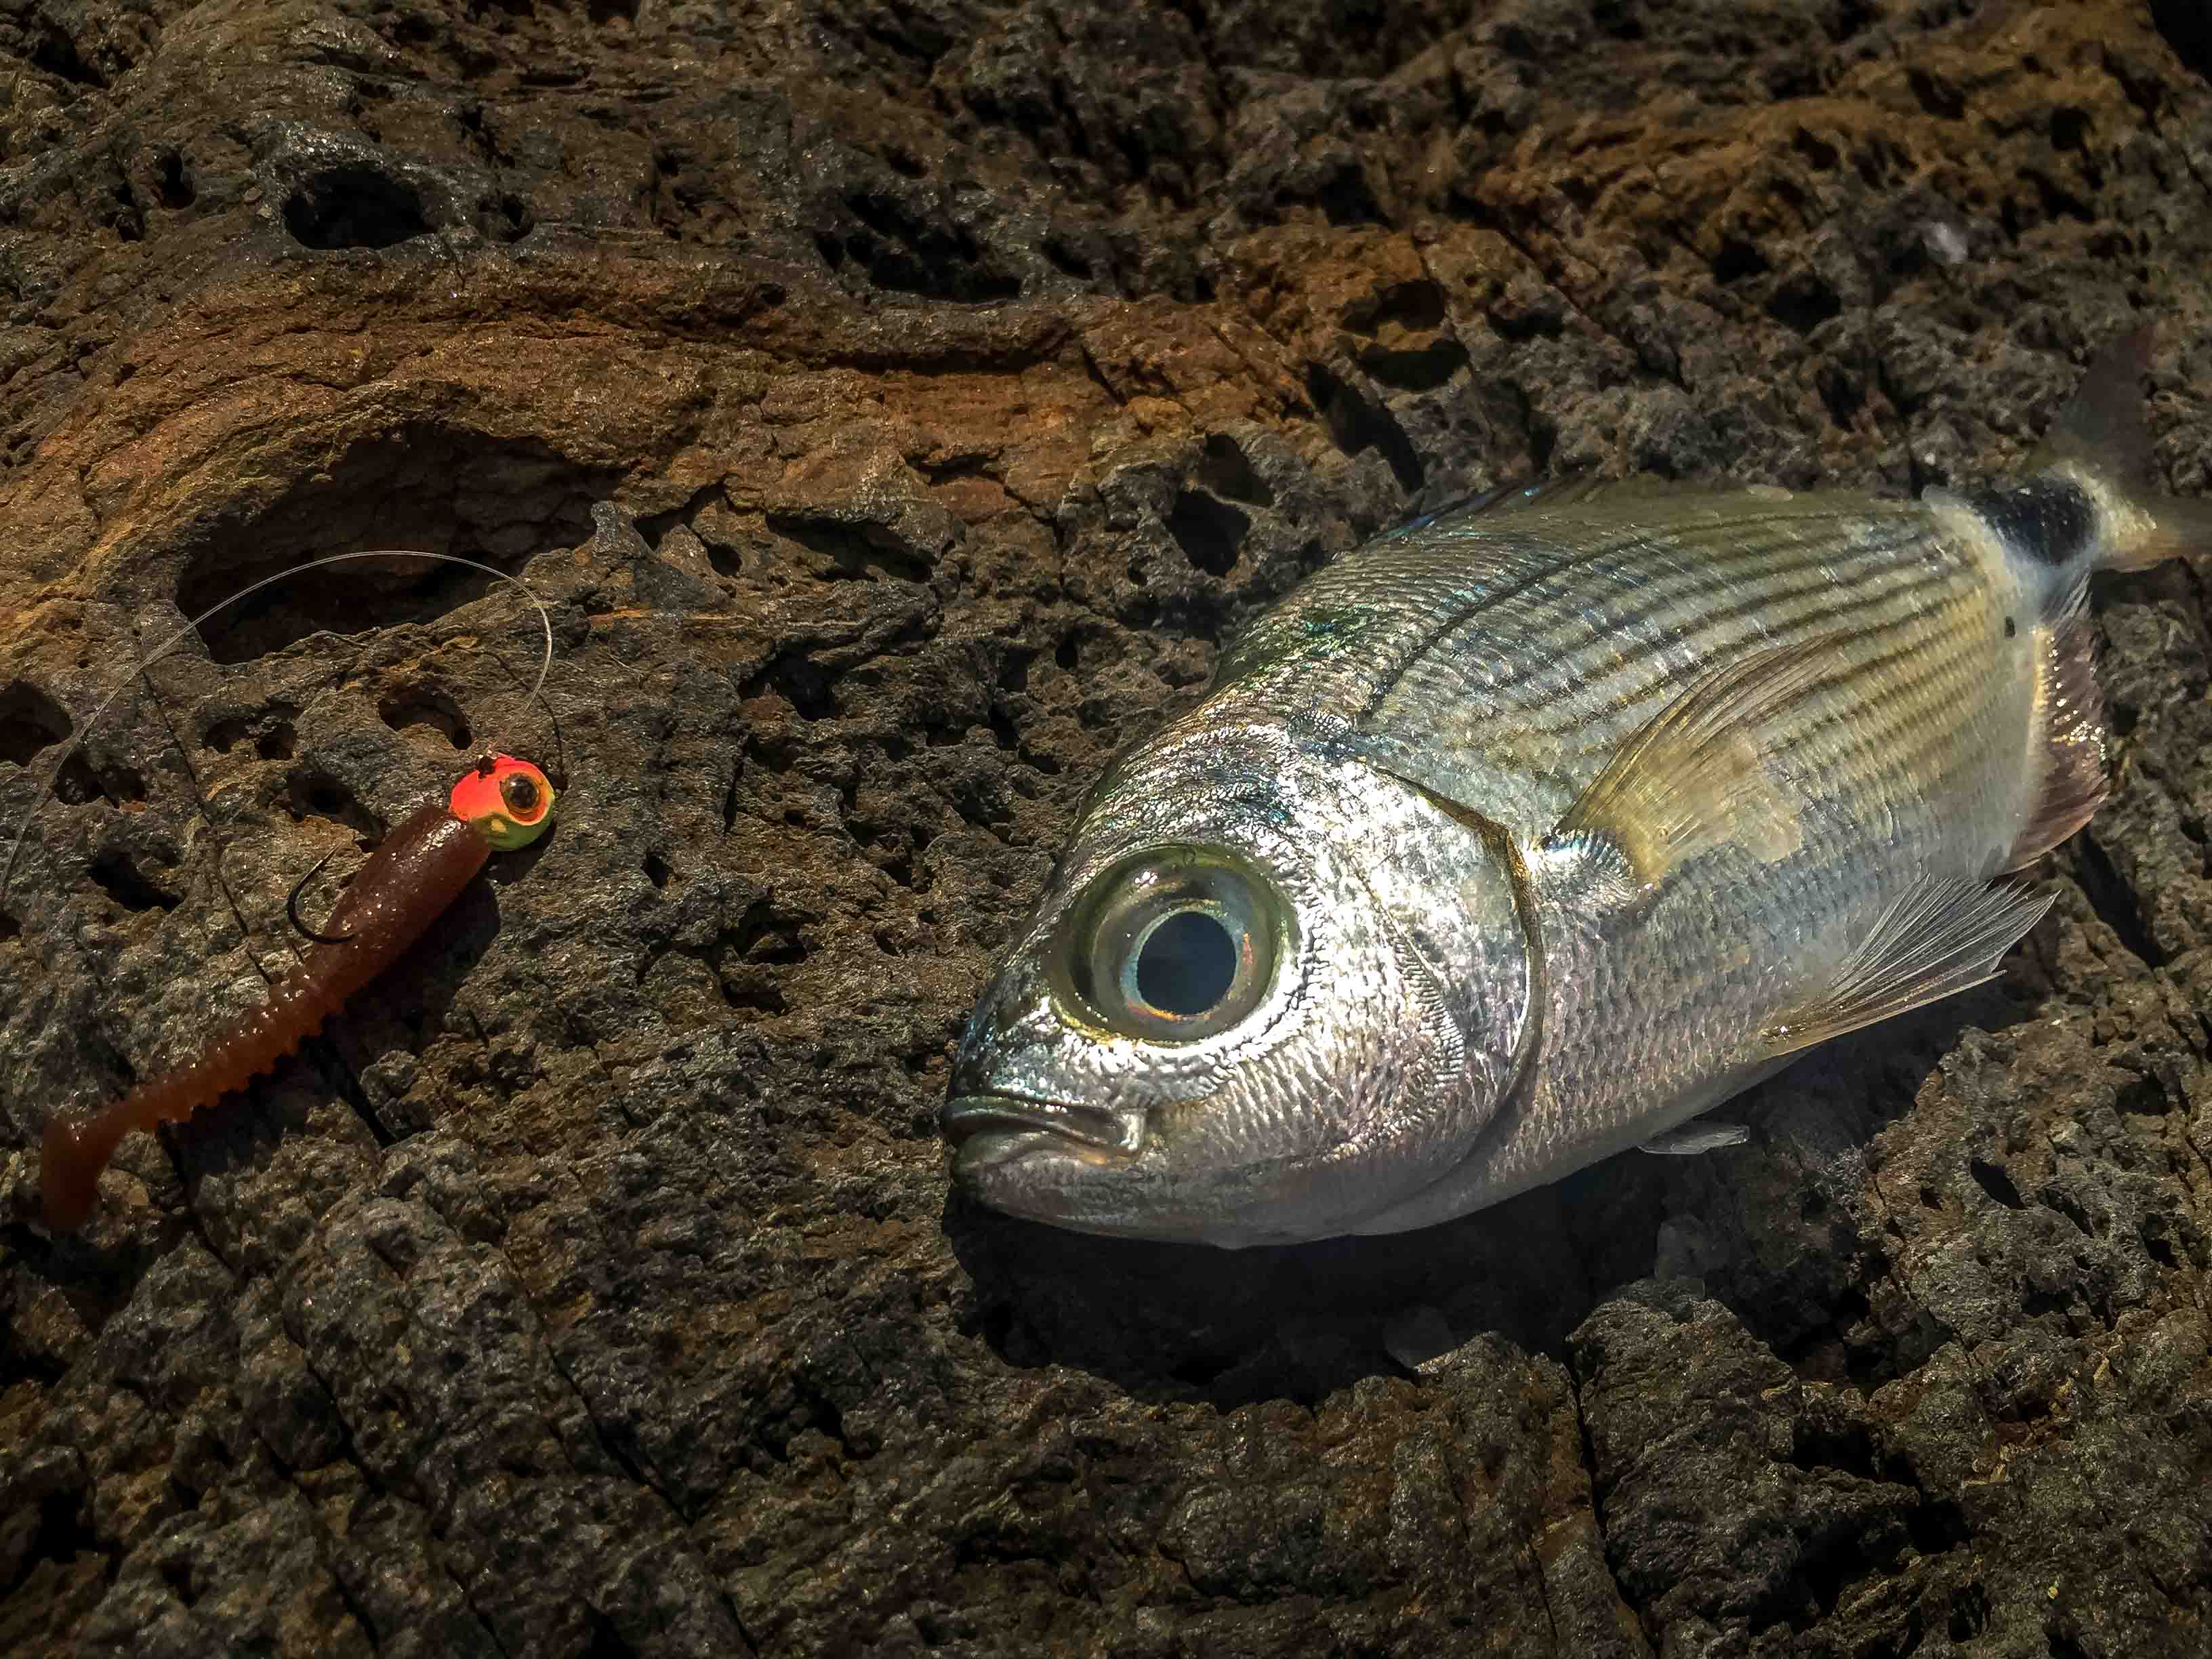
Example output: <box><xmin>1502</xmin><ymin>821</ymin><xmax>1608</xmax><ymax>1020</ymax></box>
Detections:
<box><xmin>1544</xmin><ymin>637</ymin><xmax>1838</xmax><ymax>889</ymax></box>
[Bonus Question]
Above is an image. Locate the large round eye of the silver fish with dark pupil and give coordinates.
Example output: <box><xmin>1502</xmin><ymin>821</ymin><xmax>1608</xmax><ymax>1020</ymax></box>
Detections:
<box><xmin>1059</xmin><ymin>847</ymin><xmax>1288</xmax><ymax>1042</ymax></box>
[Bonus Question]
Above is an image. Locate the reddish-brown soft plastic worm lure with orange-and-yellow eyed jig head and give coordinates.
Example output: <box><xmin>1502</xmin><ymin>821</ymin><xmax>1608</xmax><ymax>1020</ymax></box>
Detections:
<box><xmin>37</xmin><ymin>754</ymin><xmax>553</xmax><ymax>1230</ymax></box>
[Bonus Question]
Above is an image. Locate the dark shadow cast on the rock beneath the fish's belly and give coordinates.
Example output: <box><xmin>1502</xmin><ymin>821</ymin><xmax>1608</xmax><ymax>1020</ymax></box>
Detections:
<box><xmin>945</xmin><ymin>991</ymin><xmax>2028</xmax><ymax>1409</ymax></box>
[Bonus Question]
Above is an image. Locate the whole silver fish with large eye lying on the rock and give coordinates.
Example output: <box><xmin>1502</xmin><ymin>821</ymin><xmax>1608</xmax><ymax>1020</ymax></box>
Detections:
<box><xmin>945</xmin><ymin>334</ymin><xmax>2212</xmax><ymax>1246</ymax></box>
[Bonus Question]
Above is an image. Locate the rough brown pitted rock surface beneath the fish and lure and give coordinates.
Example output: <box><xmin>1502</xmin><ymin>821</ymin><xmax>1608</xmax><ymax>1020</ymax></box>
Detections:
<box><xmin>0</xmin><ymin>0</ymin><xmax>2212</xmax><ymax>1659</ymax></box>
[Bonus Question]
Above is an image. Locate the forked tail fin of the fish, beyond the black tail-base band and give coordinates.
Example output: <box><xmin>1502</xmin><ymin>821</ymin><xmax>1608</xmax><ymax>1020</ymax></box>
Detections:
<box><xmin>2028</xmin><ymin>323</ymin><xmax>2212</xmax><ymax>571</ymax></box>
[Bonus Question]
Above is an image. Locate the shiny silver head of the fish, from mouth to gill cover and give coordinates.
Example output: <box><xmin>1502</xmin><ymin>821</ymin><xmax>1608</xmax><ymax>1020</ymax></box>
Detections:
<box><xmin>945</xmin><ymin>721</ymin><xmax>1528</xmax><ymax>1246</ymax></box>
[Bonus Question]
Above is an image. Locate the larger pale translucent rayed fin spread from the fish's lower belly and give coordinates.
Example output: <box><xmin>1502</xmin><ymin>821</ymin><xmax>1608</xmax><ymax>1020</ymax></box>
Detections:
<box><xmin>1759</xmin><ymin>876</ymin><xmax>2053</xmax><ymax>1055</ymax></box>
